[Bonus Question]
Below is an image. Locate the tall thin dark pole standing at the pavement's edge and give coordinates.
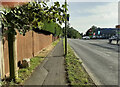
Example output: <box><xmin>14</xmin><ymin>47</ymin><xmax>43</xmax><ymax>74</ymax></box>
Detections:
<box><xmin>65</xmin><ymin>0</ymin><xmax>67</xmax><ymax>56</ymax></box>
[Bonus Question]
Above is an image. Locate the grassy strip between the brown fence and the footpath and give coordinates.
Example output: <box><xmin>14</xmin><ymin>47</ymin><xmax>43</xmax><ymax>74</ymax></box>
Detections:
<box><xmin>1</xmin><ymin>39</ymin><xmax>60</xmax><ymax>87</ymax></box>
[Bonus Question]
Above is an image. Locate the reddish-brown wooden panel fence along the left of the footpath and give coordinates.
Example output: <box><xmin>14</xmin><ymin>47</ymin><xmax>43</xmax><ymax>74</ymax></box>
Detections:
<box><xmin>3</xmin><ymin>31</ymin><xmax>58</xmax><ymax>76</ymax></box>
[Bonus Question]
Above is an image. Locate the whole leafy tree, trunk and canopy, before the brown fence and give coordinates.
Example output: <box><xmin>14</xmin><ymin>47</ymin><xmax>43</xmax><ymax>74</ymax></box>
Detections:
<box><xmin>2</xmin><ymin>2</ymin><xmax>66</xmax><ymax>80</ymax></box>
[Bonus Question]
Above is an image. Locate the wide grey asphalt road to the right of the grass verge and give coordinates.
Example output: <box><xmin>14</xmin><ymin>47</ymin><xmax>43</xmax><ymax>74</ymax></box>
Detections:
<box><xmin>68</xmin><ymin>39</ymin><xmax>118</xmax><ymax>85</ymax></box>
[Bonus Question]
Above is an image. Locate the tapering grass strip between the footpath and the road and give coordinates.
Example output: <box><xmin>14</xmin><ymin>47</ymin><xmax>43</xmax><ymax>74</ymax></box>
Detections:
<box><xmin>63</xmin><ymin>38</ymin><xmax>94</xmax><ymax>87</ymax></box>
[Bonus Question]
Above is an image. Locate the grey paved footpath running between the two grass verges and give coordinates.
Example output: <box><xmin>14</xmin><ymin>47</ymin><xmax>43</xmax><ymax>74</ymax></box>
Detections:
<box><xmin>24</xmin><ymin>40</ymin><xmax>67</xmax><ymax>86</ymax></box>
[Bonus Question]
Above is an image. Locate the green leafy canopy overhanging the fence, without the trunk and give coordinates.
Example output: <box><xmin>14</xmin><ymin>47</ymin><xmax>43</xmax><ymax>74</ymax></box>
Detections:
<box><xmin>2</xmin><ymin>2</ymin><xmax>66</xmax><ymax>35</ymax></box>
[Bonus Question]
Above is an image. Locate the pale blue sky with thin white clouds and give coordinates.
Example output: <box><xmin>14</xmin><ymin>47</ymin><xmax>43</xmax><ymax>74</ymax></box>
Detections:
<box><xmin>51</xmin><ymin>0</ymin><xmax>119</xmax><ymax>33</ymax></box>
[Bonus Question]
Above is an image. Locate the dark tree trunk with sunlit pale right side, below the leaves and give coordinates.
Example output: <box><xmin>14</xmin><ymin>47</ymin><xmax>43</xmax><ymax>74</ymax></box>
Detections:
<box><xmin>8</xmin><ymin>33</ymin><xmax>18</xmax><ymax>81</ymax></box>
